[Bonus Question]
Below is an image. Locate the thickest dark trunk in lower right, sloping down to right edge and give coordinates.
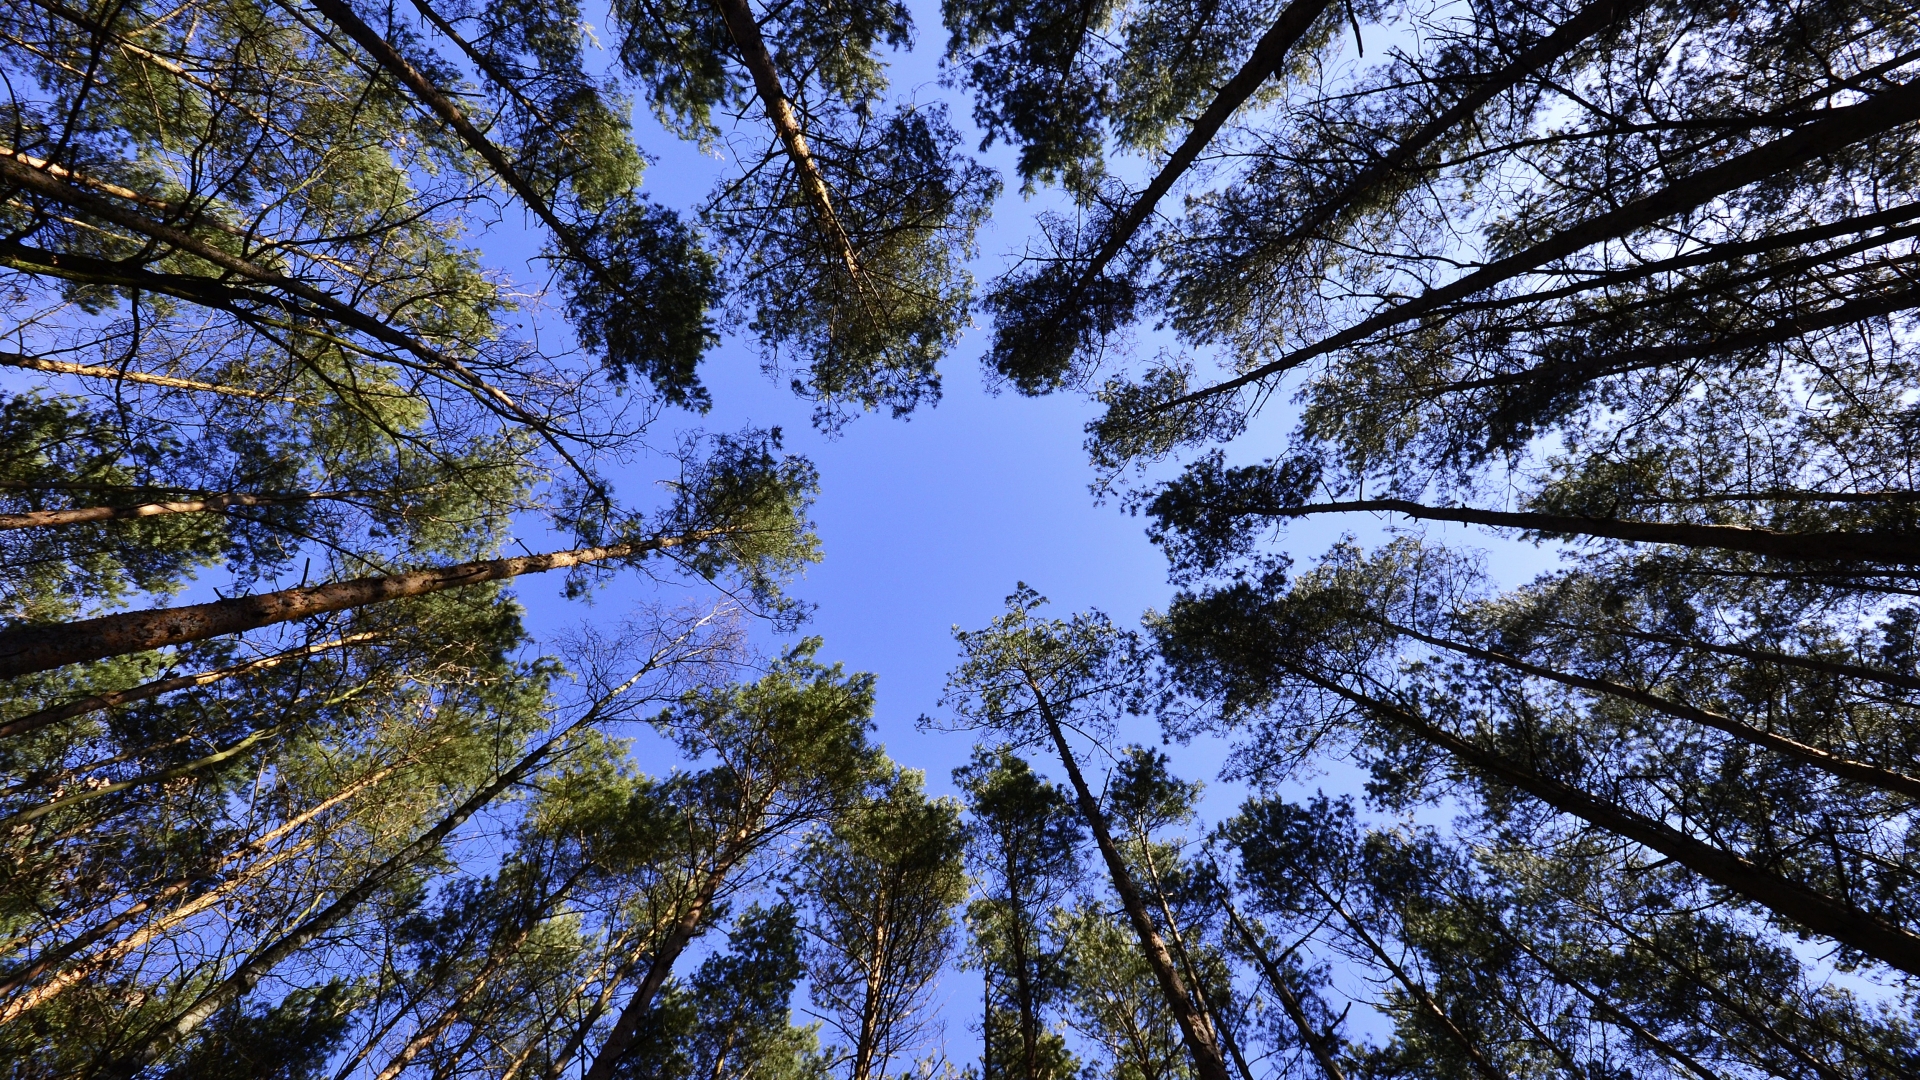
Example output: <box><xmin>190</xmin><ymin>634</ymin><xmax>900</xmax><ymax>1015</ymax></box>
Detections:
<box><xmin>1290</xmin><ymin>667</ymin><xmax>1920</xmax><ymax>974</ymax></box>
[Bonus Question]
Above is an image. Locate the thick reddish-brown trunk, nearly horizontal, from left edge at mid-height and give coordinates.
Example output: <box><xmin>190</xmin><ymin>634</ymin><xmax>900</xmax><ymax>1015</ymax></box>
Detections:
<box><xmin>0</xmin><ymin>532</ymin><xmax>710</xmax><ymax>678</ymax></box>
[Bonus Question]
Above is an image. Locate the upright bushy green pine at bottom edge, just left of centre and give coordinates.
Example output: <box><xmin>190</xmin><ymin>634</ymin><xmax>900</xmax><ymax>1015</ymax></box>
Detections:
<box><xmin>799</xmin><ymin>769</ymin><xmax>966</xmax><ymax>1080</ymax></box>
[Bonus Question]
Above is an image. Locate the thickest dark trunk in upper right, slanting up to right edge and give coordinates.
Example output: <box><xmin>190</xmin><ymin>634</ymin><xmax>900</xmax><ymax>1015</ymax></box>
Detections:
<box><xmin>1156</xmin><ymin>83</ymin><xmax>1920</xmax><ymax>409</ymax></box>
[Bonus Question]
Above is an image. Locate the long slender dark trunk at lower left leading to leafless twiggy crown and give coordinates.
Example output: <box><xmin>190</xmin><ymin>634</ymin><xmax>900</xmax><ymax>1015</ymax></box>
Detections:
<box><xmin>106</xmin><ymin>713</ymin><xmax>576</xmax><ymax>1078</ymax></box>
